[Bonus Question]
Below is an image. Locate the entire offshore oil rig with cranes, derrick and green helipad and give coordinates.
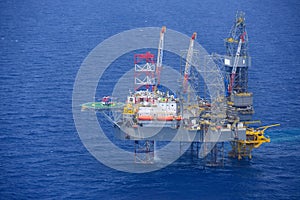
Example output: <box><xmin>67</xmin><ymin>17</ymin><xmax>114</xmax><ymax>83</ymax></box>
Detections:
<box><xmin>81</xmin><ymin>12</ymin><xmax>279</xmax><ymax>166</ymax></box>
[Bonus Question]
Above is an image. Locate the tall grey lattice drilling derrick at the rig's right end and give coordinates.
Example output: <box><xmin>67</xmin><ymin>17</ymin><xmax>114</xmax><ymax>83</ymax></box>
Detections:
<box><xmin>224</xmin><ymin>12</ymin><xmax>254</xmax><ymax>121</ymax></box>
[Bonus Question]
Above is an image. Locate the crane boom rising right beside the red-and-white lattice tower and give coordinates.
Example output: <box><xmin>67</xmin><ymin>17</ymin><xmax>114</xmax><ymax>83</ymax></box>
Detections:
<box><xmin>155</xmin><ymin>26</ymin><xmax>167</xmax><ymax>90</ymax></box>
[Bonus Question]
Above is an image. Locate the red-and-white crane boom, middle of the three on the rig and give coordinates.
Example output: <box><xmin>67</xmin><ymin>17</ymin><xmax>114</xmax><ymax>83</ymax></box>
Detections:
<box><xmin>183</xmin><ymin>32</ymin><xmax>197</xmax><ymax>93</ymax></box>
